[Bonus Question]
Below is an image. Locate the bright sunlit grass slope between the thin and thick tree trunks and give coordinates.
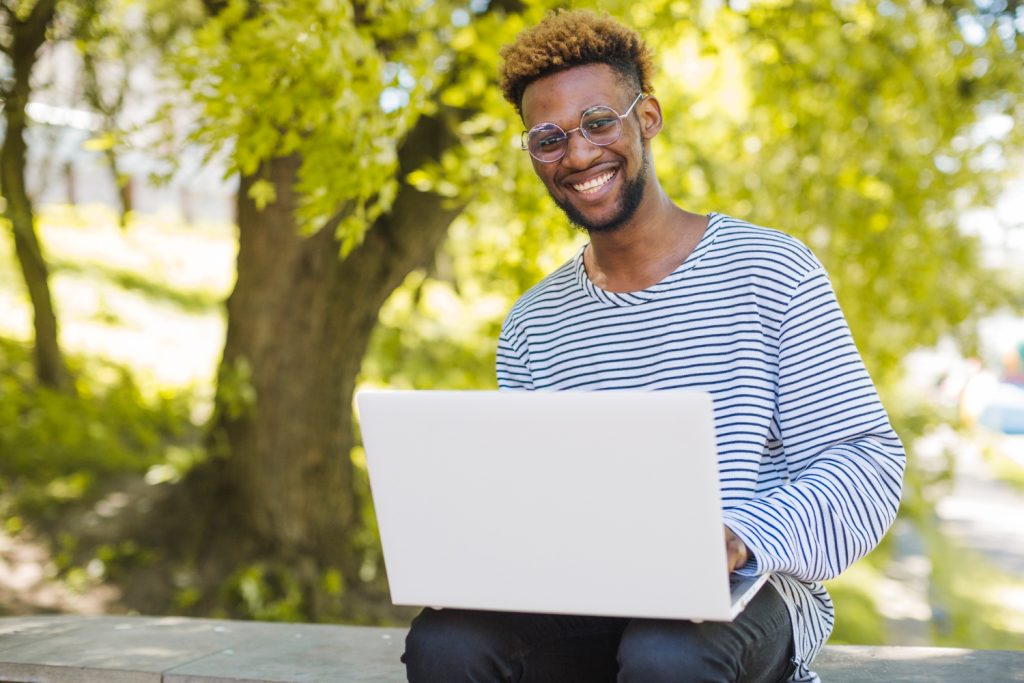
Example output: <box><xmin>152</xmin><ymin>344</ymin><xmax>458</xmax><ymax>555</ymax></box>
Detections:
<box><xmin>0</xmin><ymin>206</ymin><xmax>236</xmax><ymax>395</ymax></box>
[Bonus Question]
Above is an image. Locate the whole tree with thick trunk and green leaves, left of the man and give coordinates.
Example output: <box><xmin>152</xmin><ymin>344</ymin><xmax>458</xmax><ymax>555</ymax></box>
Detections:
<box><xmin>145</xmin><ymin>0</ymin><xmax>536</xmax><ymax>618</ymax></box>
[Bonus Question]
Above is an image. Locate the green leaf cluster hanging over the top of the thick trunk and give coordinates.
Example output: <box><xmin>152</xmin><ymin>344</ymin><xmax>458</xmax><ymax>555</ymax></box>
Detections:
<box><xmin>171</xmin><ymin>0</ymin><xmax>456</xmax><ymax>248</ymax></box>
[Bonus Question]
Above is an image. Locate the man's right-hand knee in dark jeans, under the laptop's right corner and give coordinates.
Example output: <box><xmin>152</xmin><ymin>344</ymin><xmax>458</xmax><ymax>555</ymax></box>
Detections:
<box><xmin>618</xmin><ymin>621</ymin><xmax>737</xmax><ymax>683</ymax></box>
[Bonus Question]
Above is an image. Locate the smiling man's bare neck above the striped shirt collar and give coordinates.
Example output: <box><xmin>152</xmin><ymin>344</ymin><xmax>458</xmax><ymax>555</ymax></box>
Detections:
<box><xmin>584</xmin><ymin>184</ymin><xmax>708</xmax><ymax>292</ymax></box>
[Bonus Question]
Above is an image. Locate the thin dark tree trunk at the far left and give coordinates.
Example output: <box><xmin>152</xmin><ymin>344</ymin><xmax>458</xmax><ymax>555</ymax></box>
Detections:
<box><xmin>0</xmin><ymin>0</ymin><xmax>72</xmax><ymax>389</ymax></box>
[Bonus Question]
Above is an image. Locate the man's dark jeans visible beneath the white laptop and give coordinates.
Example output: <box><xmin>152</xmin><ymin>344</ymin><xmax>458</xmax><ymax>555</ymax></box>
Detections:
<box><xmin>401</xmin><ymin>586</ymin><xmax>793</xmax><ymax>683</ymax></box>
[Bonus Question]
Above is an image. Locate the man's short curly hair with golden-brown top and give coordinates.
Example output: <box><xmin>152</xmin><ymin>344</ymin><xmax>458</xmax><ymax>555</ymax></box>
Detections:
<box><xmin>501</xmin><ymin>9</ymin><xmax>654</xmax><ymax>116</ymax></box>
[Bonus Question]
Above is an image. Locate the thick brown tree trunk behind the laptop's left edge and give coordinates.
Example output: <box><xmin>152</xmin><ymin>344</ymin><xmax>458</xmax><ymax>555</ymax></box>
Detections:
<box><xmin>171</xmin><ymin>112</ymin><xmax>461</xmax><ymax>618</ymax></box>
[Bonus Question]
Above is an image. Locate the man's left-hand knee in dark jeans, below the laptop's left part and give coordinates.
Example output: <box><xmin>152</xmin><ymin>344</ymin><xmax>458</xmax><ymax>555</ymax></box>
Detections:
<box><xmin>401</xmin><ymin>608</ymin><xmax>508</xmax><ymax>683</ymax></box>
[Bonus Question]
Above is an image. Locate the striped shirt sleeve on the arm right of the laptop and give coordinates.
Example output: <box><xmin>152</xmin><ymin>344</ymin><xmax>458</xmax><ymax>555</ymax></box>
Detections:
<box><xmin>724</xmin><ymin>267</ymin><xmax>906</xmax><ymax>581</ymax></box>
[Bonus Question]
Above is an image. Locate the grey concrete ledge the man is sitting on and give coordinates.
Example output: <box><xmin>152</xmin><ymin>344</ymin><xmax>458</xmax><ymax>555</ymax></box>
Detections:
<box><xmin>0</xmin><ymin>616</ymin><xmax>1024</xmax><ymax>683</ymax></box>
